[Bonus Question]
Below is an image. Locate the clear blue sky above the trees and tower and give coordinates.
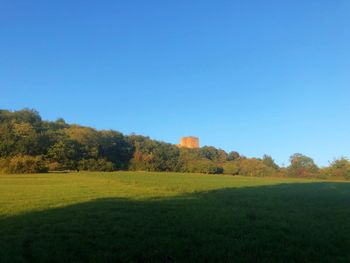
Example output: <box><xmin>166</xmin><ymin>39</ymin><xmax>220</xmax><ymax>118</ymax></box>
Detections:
<box><xmin>0</xmin><ymin>0</ymin><xmax>350</xmax><ymax>165</ymax></box>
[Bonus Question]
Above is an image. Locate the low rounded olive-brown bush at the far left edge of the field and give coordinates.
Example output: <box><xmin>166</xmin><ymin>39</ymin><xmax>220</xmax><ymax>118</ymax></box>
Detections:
<box><xmin>0</xmin><ymin>155</ymin><xmax>48</xmax><ymax>173</ymax></box>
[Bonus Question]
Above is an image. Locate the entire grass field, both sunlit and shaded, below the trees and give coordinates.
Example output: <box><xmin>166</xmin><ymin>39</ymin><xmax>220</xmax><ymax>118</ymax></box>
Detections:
<box><xmin>0</xmin><ymin>172</ymin><xmax>350</xmax><ymax>263</ymax></box>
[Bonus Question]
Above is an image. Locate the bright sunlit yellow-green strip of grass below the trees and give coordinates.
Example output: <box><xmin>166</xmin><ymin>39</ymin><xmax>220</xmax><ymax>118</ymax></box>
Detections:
<box><xmin>0</xmin><ymin>172</ymin><xmax>317</xmax><ymax>216</ymax></box>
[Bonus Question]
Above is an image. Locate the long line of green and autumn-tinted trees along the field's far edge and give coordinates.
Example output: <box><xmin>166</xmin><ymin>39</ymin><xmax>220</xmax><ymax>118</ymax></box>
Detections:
<box><xmin>0</xmin><ymin>109</ymin><xmax>350</xmax><ymax>179</ymax></box>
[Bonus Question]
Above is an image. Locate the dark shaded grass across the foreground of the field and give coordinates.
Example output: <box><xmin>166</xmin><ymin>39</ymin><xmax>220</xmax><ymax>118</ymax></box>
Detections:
<box><xmin>0</xmin><ymin>183</ymin><xmax>350</xmax><ymax>263</ymax></box>
